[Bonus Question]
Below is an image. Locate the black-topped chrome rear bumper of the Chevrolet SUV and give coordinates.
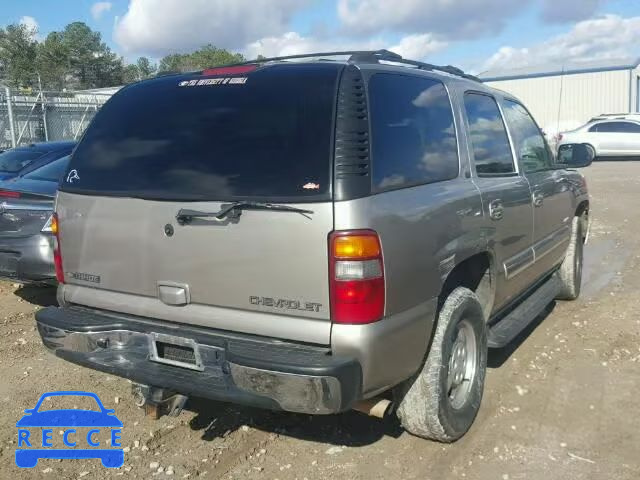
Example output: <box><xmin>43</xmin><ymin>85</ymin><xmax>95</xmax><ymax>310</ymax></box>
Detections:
<box><xmin>36</xmin><ymin>307</ymin><xmax>362</xmax><ymax>414</ymax></box>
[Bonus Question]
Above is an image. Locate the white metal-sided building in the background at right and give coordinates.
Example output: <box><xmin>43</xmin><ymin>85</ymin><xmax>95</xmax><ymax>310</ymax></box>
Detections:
<box><xmin>480</xmin><ymin>59</ymin><xmax>640</xmax><ymax>136</ymax></box>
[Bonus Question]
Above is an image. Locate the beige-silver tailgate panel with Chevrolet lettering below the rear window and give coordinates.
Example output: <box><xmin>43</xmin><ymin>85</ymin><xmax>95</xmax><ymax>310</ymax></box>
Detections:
<box><xmin>57</xmin><ymin>192</ymin><xmax>333</xmax><ymax>344</ymax></box>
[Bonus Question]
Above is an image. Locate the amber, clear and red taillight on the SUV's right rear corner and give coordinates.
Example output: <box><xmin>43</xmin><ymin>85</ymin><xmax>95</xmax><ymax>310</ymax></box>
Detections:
<box><xmin>329</xmin><ymin>230</ymin><xmax>385</xmax><ymax>324</ymax></box>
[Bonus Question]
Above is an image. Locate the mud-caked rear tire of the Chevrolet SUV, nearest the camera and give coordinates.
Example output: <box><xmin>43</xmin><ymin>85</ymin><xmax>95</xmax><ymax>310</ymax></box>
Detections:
<box><xmin>397</xmin><ymin>287</ymin><xmax>487</xmax><ymax>443</ymax></box>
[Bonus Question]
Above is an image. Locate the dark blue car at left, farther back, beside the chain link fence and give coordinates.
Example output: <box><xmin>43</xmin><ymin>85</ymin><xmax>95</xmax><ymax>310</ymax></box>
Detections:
<box><xmin>0</xmin><ymin>141</ymin><xmax>76</xmax><ymax>180</ymax></box>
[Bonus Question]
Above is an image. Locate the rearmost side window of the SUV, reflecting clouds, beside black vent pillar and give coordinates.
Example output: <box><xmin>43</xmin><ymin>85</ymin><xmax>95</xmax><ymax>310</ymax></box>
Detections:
<box><xmin>369</xmin><ymin>73</ymin><xmax>458</xmax><ymax>192</ymax></box>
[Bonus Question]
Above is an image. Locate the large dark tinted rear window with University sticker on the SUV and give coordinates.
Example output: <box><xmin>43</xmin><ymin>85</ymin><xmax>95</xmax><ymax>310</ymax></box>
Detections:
<box><xmin>62</xmin><ymin>64</ymin><xmax>342</xmax><ymax>201</ymax></box>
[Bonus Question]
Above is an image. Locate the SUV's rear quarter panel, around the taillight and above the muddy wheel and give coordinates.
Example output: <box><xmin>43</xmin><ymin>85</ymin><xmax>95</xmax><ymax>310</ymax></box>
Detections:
<box><xmin>331</xmin><ymin>179</ymin><xmax>490</xmax><ymax>397</ymax></box>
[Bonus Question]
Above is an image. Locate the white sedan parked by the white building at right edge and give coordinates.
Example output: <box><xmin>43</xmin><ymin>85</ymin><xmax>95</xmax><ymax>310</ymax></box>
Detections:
<box><xmin>558</xmin><ymin>118</ymin><xmax>640</xmax><ymax>157</ymax></box>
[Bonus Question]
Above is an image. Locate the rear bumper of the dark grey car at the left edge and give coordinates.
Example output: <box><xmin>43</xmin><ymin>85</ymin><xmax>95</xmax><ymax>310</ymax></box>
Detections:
<box><xmin>0</xmin><ymin>233</ymin><xmax>56</xmax><ymax>284</ymax></box>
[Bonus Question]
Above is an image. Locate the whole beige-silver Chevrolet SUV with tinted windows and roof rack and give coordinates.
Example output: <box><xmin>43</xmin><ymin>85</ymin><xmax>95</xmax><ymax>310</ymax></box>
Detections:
<box><xmin>36</xmin><ymin>51</ymin><xmax>593</xmax><ymax>442</ymax></box>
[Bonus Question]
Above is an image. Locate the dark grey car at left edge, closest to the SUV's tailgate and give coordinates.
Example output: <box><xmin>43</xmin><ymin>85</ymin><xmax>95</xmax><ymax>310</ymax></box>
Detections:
<box><xmin>0</xmin><ymin>156</ymin><xmax>69</xmax><ymax>284</ymax></box>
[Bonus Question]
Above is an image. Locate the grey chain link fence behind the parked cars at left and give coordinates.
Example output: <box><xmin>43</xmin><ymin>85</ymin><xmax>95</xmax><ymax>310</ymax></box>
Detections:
<box><xmin>0</xmin><ymin>87</ymin><xmax>117</xmax><ymax>150</ymax></box>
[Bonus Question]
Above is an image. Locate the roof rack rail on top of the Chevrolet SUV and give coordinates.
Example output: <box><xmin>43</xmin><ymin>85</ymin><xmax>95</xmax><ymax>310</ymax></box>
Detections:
<box><xmin>226</xmin><ymin>49</ymin><xmax>482</xmax><ymax>83</ymax></box>
